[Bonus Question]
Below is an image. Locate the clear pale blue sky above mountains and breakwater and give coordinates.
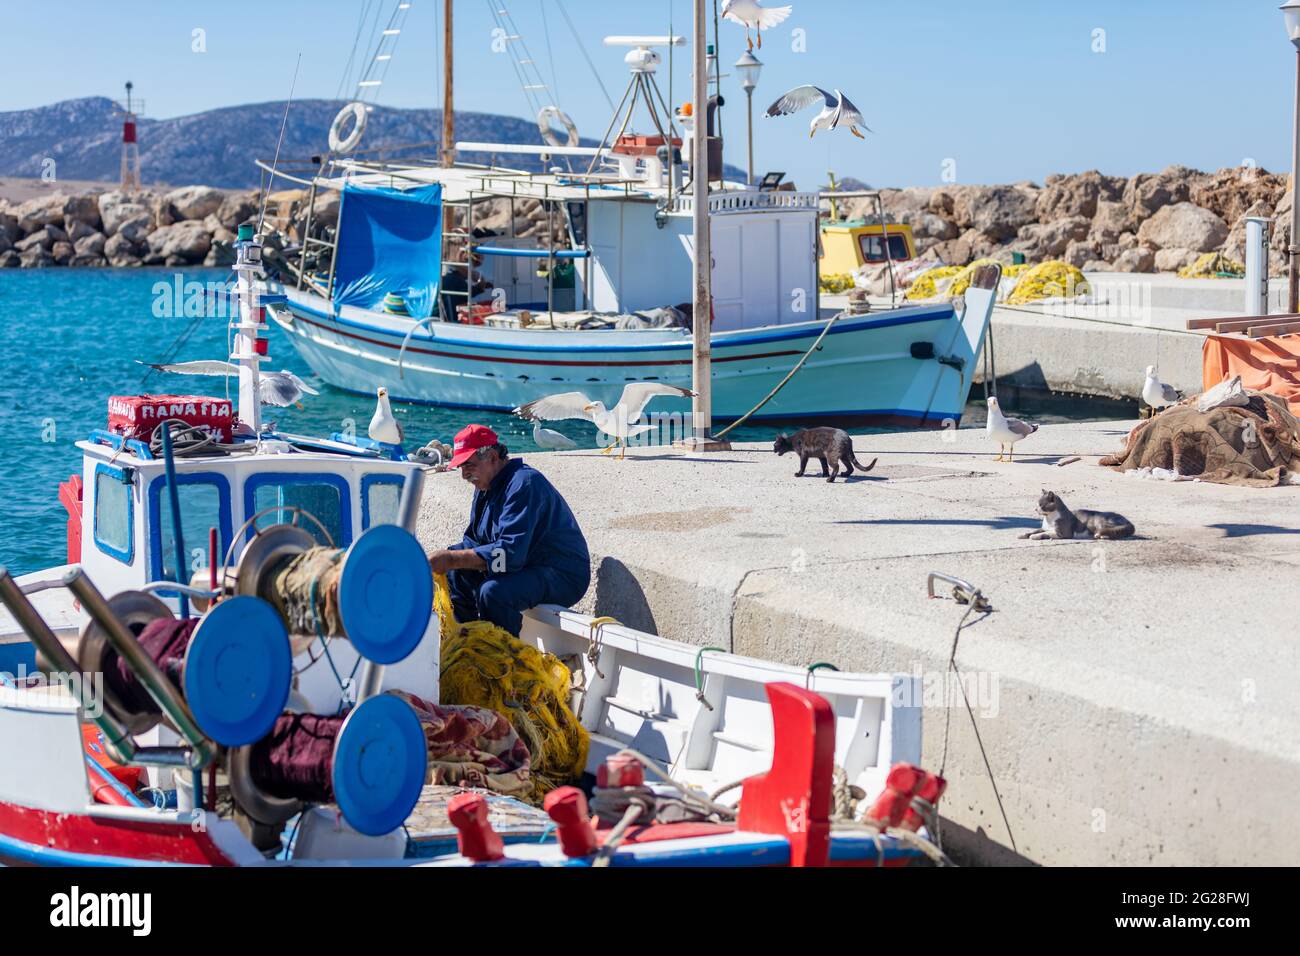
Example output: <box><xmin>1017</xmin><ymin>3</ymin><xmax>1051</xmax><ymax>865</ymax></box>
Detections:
<box><xmin>0</xmin><ymin>0</ymin><xmax>1295</xmax><ymax>186</ymax></box>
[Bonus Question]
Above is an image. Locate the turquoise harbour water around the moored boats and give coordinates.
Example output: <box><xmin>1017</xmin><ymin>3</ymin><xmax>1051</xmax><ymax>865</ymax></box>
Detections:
<box><xmin>0</xmin><ymin>268</ymin><xmax>1125</xmax><ymax>575</ymax></box>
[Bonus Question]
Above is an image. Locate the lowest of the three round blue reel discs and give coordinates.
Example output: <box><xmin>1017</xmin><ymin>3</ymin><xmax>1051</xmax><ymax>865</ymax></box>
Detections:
<box><xmin>333</xmin><ymin>695</ymin><xmax>429</xmax><ymax>836</ymax></box>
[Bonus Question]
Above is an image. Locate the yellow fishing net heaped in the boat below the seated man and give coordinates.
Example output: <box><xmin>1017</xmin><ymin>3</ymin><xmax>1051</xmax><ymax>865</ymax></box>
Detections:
<box><xmin>433</xmin><ymin>575</ymin><xmax>590</xmax><ymax>803</ymax></box>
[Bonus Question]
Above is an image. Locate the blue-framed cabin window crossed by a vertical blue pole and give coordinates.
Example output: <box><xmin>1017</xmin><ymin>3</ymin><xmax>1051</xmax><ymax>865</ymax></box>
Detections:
<box><xmin>150</xmin><ymin>472</ymin><xmax>231</xmax><ymax>581</ymax></box>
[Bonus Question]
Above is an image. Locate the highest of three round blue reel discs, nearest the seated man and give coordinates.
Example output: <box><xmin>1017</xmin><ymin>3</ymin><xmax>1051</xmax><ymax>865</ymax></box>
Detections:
<box><xmin>338</xmin><ymin>524</ymin><xmax>433</xmax><ymax>663</ymax></box>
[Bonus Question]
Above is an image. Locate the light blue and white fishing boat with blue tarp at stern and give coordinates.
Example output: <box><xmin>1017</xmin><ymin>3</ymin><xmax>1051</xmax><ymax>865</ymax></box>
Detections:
<box><xmin>261</xmin><ymin>11</ymin><xmax>992</xmax><ymax>427</ymax></box>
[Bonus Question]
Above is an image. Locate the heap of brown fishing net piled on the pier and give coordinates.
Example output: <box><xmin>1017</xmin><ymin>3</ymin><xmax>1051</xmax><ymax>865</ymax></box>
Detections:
<box><xmin>1100</xmin><ymin>392</ymin><xmax>1300</xmax><ymax>488</ymax></box>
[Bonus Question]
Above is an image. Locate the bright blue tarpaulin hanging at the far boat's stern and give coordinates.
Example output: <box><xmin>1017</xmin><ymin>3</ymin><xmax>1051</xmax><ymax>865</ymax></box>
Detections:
<box><xmin>334</xmin><ymin>183</ymin><xmax>442</xmax><ymax>319</ymax></box>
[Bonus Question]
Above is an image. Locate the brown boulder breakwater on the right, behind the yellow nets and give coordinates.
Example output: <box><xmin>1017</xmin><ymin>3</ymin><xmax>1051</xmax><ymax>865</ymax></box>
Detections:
<box><xmin>845</xmin><ymin>166</ymin><xmax>1292</xmax><ymax>274</ymax></box>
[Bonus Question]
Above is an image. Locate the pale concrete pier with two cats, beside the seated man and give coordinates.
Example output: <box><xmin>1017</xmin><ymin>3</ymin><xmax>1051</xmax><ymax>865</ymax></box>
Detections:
<box><xmin>420</xmin><ymin>421</ymin><xmax>1300</xmax><ymax>865</ymax></box>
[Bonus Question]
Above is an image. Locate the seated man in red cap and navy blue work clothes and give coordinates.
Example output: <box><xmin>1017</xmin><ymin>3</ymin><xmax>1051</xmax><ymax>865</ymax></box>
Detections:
<box><xmin>429</xmin><ymin>425</ymin><xmax>592</xmax><ymax>636</ymax></box>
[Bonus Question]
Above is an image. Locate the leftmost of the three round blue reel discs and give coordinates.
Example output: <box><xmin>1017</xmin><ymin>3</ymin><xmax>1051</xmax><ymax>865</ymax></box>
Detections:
<box><xmin>182</xmin><ymin>596</ymin><xmax>294</xmax><ymax>747</ymax></box>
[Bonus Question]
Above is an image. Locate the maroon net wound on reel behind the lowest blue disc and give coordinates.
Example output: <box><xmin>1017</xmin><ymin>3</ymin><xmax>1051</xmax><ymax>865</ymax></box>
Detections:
<box><xmin>248</xmin><ymin>714</ymin><xmax>347</xmax><ymax>804</ymax></box>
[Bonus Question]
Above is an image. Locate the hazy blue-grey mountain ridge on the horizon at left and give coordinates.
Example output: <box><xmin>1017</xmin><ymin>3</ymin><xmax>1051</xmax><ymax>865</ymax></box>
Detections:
<box><xmin>0</xmin><ymin>96</ymin><xmax>744</xmax><ymax>189</ymax></box>
